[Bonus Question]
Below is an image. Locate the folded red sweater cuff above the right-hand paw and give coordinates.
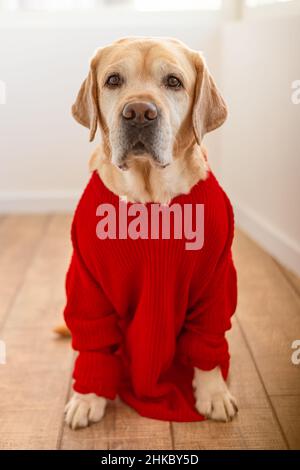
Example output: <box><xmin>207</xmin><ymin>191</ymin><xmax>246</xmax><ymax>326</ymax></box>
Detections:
<box><xmin>177</xmin><ymin>331</ymin><xmax>230</xmax><ymax>378</ymax></box>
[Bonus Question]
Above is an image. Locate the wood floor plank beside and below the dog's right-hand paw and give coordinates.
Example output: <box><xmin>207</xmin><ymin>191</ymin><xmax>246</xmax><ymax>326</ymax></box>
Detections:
<box><xmin>172</xmin><ymin>322</ymin><xmax>286</xmax><ymax>450</ymax></box>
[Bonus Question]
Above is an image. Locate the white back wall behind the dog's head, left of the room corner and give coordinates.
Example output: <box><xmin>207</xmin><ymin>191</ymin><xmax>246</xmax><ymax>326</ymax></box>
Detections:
<box><xmin>0</xmin><ymin>11</ymin><xmax>219</xmax><ymax>212</ymax></box>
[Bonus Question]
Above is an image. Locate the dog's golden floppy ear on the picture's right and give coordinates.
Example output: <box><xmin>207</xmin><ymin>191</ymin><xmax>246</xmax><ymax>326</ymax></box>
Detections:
<box><xmin>192</xmin><ymin>54</ymin><xmax>227</xmax><ymax>144</ymax></box>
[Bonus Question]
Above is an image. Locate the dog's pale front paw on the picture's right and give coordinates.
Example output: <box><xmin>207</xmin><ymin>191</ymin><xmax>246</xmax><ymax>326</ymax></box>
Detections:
<box><xmin>193</xmin><ymin>367</ymin><xmax>238</xmax><ymax>421</ymax></box>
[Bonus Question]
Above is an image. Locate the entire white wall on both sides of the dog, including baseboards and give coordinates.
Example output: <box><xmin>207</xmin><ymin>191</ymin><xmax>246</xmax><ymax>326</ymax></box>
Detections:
<box><xmin>0</xmin><ymin>11</ymin><xmax>300</xmax><ymax>274</ymax></box>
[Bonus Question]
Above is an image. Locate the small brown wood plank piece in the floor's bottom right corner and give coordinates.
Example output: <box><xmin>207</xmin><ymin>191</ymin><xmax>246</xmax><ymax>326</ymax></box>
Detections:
<box><xmin>271</xmin><ymin>395</ymin><xmax>300</xmax><ymax>450</ymax></box>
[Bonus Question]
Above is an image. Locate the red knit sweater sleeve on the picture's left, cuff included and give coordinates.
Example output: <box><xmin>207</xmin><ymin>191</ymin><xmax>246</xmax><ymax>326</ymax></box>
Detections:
<box><xmin>64</xmin><ymin>222</ymin><xmax>121</xmax><ymax>399</ymax></box>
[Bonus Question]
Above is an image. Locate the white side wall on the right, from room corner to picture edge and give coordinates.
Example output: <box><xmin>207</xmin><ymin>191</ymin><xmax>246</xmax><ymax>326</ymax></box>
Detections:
<box><xmin>220</xmin><ymin>17</ymin><xmax>300</xmax><ymax>274</ymax></box>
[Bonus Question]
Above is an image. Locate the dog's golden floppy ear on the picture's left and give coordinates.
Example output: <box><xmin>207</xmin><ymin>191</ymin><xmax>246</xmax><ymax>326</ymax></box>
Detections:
<box><xmin>72</xmin><ymin>54</ymin><xmax>100</xmax><ymax>142</ymax></box>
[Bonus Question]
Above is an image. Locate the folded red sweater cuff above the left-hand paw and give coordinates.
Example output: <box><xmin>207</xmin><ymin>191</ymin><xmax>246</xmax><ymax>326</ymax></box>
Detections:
<box><xmin>73</xmin><ymin>351</ymin><xmax>121</xmax><ymax>400</ymax></box>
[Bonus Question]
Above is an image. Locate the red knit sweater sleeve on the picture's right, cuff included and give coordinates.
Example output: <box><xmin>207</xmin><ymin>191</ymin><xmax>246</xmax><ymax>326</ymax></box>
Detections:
<box><xmin>177</xmin><ymin>193</ymin><xmax>237</xmax><ymax>378</ymax></box>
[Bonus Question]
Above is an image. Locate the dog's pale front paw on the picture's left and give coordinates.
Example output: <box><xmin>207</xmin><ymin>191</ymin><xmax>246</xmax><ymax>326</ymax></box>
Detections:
<box><xmin>65</xmin><ymin>392</ymin><xmax>107</xmax><ymax>429</ymax></box>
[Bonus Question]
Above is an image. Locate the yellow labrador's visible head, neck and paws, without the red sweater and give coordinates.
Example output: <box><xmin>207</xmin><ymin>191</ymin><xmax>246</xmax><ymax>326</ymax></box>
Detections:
<box><xmin>60</xmin><ymin>37</ymin><xmax>237</xmax><ymax>428</ymax></box>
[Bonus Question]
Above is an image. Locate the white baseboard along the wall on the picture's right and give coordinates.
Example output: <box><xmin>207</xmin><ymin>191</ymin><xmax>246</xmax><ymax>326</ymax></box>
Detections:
<box><xmin>233</xmin><ymin>203</ymin><xmax>300</xmax><ymax>276</ymax></box>
